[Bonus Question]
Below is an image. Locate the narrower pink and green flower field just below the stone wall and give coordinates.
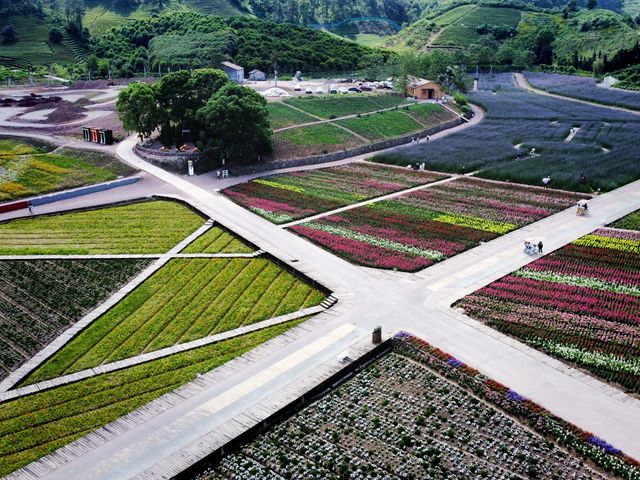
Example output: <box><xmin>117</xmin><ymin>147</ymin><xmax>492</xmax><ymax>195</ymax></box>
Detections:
<box><xmin>224</xmin><ymin>163</ymin><xmax>447</xmax><ymax>223</ymax></box>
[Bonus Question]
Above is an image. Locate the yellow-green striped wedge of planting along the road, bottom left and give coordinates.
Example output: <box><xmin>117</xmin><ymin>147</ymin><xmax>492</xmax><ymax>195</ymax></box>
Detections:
<box><xmin>0</xmin><ymin>320</ymin><xmax>303</xmax><ymax>475</ymax></box>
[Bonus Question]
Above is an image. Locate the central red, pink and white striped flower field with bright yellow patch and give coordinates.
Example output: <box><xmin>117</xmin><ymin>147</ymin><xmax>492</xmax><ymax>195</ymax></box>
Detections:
<box><xmin>291</xmin><ymin>178</ymin><xmax>578</xmax><ymax>271</ymax></box>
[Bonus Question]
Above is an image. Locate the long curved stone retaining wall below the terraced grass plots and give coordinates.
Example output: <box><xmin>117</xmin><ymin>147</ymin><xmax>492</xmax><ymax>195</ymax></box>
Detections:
<box><xmin>229</xmin><ymin>117</ymin><xmax>464</xmax><ymax>177</ymax></box>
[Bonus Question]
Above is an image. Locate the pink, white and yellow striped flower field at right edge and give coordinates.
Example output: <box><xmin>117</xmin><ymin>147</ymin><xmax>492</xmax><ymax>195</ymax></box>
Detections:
<box><xmin>456</xmin><ymin>228</ymin><xmax>640</xmax><ymax>393</ymax></box>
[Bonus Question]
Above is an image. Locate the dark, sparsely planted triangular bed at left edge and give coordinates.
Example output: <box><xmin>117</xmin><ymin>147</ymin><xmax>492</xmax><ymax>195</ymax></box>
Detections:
<box><xmin>0</xmin><ymin>260</ymin><xmax>148</xmax><ymax>380</ymax></box>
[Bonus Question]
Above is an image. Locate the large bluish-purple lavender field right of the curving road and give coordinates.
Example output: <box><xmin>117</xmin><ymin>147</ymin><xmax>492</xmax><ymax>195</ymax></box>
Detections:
<box><xmin>374</xmin><ymin>74</ymin><xmax>640</xmax><ymax>192</ymax></box>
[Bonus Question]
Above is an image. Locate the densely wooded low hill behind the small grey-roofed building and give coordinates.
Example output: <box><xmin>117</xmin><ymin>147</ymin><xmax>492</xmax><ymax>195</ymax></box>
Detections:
<box><xmin>92</xmin><ymin>12</ymin><xmax>378</xmax><ymax>76</ymax></box>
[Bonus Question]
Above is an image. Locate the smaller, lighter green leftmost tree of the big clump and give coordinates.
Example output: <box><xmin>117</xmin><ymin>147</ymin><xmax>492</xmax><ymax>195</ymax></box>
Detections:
<box><xmin>116</xmin><ymin>83</ymin><xmax>161</xmax><ymax>140</ymax></box>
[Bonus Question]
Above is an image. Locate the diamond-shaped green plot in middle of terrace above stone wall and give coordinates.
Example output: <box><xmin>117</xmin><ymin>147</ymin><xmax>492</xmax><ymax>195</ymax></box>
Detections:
<box><xmin>339</xmin><ymin>110</ymin><xmax>424</xmax><ymax>141</ymax></box>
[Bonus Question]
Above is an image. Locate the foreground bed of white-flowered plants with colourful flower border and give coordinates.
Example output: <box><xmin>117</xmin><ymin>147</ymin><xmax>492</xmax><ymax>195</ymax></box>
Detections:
<box><xmin>198</xmin><ymin>332</ymin><xmax>640</xmax><ymax>480</ymax></box>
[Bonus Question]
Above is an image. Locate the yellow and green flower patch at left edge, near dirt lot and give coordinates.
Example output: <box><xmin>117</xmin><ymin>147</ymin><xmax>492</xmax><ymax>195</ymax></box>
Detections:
<box><xmin>0</xmin><ymin>139</ymin><xmax>134</xmax><ymax>202</ymax></box>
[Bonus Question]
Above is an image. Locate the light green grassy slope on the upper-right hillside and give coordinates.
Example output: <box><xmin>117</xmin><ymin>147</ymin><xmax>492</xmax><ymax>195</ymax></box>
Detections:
<box><xmin>433</xmin><ymin>7</ymin><xmax>521</xmax><ymax>46</ymax></box>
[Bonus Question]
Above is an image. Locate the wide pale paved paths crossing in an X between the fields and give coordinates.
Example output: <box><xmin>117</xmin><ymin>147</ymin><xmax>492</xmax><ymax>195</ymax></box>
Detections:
<box><xmin>10</xmin><ymin>127</ymin><xmax>640</xmax><ymax>480</ymax></box>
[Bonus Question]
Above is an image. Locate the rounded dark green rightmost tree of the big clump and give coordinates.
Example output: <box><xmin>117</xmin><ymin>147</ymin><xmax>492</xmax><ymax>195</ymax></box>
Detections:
<box><xmin>197</xmin><ymin>83</ymin><xmax>273</xmax><ymax>162</ymax></box>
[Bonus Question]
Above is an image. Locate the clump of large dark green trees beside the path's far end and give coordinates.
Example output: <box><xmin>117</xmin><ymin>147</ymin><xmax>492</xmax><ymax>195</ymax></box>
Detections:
<box><xmin>116</xmin><ymin>69</ymin><xmax>272</xmax><ymax>162</ymax></box>
